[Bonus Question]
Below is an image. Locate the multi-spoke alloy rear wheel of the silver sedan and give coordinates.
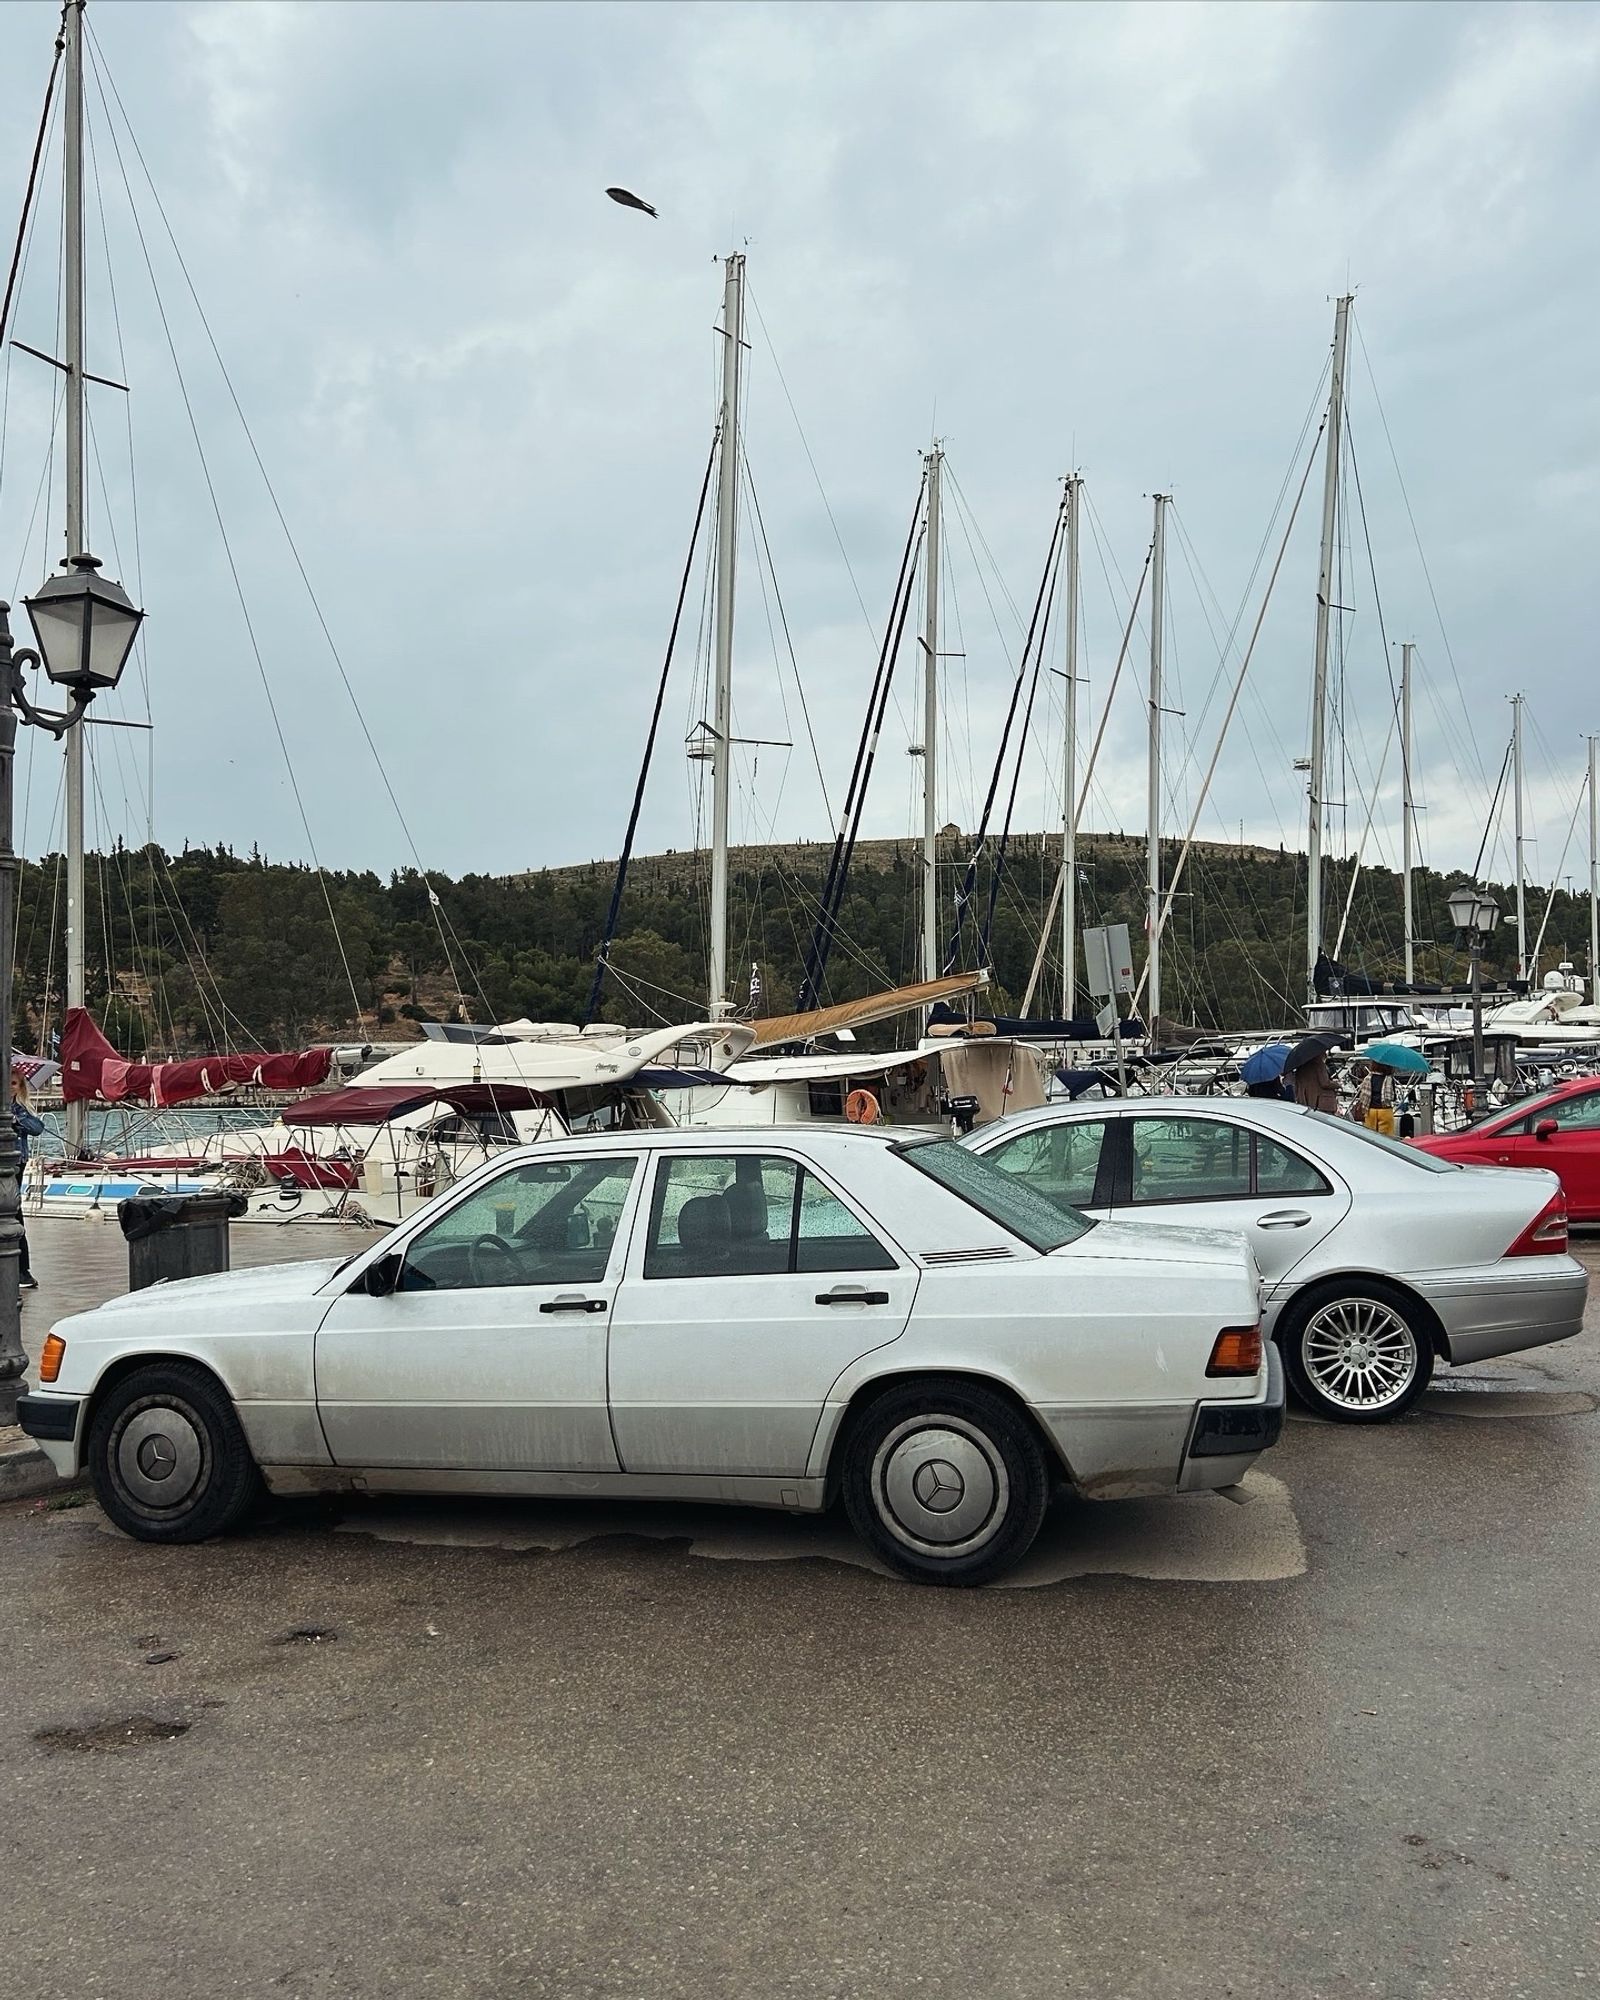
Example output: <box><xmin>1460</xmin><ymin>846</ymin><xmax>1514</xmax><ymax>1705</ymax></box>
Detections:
<box><xmin>1276</xmin><ymin>1278</ymin><xmax>1434</xmax><ymax>1424</ymax></box>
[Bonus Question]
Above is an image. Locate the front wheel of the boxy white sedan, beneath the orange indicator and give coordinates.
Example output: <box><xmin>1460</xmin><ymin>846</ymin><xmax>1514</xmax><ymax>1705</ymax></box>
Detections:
<box><xmin>88</xmin><ymin>1362</ymin><xmax>262</xmax><ymax>1542</ymax></box>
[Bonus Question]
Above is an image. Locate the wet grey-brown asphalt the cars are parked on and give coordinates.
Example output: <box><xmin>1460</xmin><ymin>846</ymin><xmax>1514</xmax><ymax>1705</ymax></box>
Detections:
<box><xmin>0</xmin><ymin>1224</ymin><xmax>1600</xmax><ymax>2000</ymax></box>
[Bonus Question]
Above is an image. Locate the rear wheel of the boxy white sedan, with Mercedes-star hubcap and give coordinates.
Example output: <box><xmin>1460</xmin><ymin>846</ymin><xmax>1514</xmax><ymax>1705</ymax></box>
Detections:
<box><xmin>844</xmin><ymin>1376</ymin><xmax>1050</xmax><ymax>1584</ymax></box>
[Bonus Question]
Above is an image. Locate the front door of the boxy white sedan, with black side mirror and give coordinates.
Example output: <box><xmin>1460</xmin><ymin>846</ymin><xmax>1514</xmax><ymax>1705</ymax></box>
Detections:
<box><xmin>316</xmin><ymin>1154</ymin><xmax>640</xmax><ymax>1474</ymax></box>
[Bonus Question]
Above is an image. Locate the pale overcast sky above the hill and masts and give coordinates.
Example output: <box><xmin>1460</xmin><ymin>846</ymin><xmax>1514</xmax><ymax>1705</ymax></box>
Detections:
<box><xmin>0</xmin><ymin>0</ymin><xmax>1600</xmax><ymax>896</ymax></box>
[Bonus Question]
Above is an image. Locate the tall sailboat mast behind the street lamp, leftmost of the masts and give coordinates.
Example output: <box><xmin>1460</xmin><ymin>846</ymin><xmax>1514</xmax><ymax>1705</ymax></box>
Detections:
<box><xmin>62</xmin><ymin>0</ymin><xmax>88</xmax><ymax>1158</ymax></box>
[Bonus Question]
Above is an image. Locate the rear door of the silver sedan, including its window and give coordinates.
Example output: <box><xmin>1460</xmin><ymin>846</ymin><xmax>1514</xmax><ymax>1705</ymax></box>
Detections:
<box><xmin>1112</xmin><ymin>1112</ymin><xmax>1350</xmax><ymax>1284</ymax></box>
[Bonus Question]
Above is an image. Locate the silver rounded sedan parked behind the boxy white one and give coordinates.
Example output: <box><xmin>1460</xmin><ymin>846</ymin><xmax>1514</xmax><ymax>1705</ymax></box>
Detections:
<box><xmin>962</xmin><ymin>1098</ymin><xmax>1588</xmax><ymax>1424</ymax></box>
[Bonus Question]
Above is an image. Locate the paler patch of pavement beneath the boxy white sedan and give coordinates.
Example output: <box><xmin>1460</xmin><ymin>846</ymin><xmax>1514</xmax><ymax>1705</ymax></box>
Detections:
<box><xmin>338</xmin><ymin>1472</ymin><xmax>1306</xmax><ymax>1590</ymax></box>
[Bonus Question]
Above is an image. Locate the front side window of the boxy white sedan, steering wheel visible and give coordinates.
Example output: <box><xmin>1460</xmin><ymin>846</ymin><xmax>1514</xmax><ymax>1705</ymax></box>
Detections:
<box><xmin>398</xmin><ymin>1158</ymin><xmax>638</xmax><ymax>1292</ymax></box>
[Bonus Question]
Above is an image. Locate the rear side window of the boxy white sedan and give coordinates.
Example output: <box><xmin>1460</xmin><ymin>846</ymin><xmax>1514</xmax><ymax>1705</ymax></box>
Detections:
<box><xmin>644</xmin><ymin>1152</ymin><xmax>894</xmax><ymax>1278</ymax></box>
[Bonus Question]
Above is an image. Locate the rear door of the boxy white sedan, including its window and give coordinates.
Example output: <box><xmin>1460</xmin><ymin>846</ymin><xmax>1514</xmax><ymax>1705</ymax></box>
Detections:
<box><xmin>610</xmin><ymin>1150</ymin><xmax>918</xmax><ymax>1476</ymax></box>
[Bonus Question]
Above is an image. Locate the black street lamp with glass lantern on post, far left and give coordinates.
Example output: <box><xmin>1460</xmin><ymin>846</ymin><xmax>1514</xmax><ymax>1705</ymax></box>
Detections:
<box><xmin>0</xmin><ymin>556</ymin><xmax>144</xmax><ymax>1424</ymax></box>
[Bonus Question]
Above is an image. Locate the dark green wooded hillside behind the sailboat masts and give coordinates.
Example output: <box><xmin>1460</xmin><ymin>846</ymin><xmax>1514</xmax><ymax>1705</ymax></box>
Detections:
<box><xmin>14</xmin><ymin>836</ymin><xmax>1588</xmax><ymax>1054</ymax></box>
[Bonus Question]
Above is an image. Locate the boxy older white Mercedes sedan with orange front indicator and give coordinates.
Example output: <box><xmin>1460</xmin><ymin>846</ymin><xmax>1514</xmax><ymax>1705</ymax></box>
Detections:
<box><xmin>20</xmin><ymin>1126</ymin><xmax>1284</xmax><ymax>1584</ymax></box>
